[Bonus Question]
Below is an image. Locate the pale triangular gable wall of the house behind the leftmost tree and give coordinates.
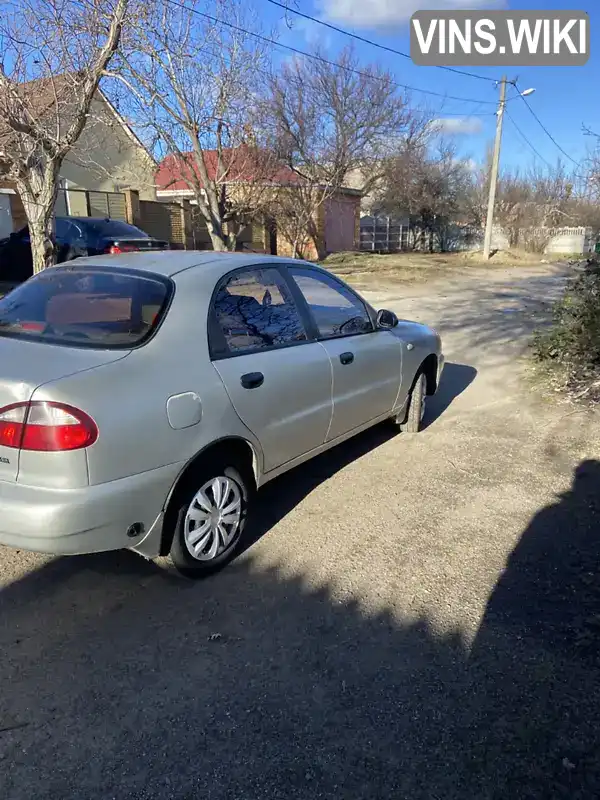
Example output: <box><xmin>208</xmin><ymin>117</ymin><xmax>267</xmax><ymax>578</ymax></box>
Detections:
<box><xmin>60</xmin><ymin>97</ymin><xmax>156</xmax><ymax>200</ymax></box>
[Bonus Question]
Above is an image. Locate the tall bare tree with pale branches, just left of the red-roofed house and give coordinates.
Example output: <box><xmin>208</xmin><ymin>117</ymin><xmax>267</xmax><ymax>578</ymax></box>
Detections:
<box><xmin>117</xmin><ymin>0</ymin><xmax>277</xmax><ymax>250</ymax></box>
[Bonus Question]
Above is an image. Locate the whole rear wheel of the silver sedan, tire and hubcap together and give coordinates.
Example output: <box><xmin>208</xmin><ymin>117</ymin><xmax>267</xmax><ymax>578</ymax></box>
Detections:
<box><xmin>170</xmin><ymin>463</ymin><xmax>250</xmax><ymax>578</ymax></box>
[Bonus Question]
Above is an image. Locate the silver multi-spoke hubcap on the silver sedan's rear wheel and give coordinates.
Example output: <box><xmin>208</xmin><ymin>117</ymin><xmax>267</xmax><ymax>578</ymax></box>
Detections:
<box><xmin>184</xmin><ymin>475</ymin><xmax>242</xmax><ymax>561</ymax></box>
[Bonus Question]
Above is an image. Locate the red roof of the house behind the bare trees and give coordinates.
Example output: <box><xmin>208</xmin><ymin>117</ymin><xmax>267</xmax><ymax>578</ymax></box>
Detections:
<box><xmin>156</xmin><ymin>147</ymin><xmax>302</xmax><ymax>191</ymax></box>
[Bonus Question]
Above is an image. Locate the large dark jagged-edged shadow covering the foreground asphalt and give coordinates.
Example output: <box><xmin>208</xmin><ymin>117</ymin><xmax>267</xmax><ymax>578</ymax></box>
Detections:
<box><xmin>0</xmin><ymin>476</ymin><xmax>600</xmax><ymax>800</ymax></box>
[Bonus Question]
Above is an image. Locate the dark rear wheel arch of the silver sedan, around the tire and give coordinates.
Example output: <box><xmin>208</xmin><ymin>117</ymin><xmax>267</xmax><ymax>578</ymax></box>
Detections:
<box><xmin>160</xmin><ymin>436</ymin><xmax>260</xmax><ymax>556</ymax></box>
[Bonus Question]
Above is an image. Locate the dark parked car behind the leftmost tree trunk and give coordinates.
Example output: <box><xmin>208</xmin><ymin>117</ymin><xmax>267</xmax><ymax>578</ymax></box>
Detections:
<box><xmin>0</xmin><ymin>217</ymin><xmax>169</xmax><ymax>283</ymax></box>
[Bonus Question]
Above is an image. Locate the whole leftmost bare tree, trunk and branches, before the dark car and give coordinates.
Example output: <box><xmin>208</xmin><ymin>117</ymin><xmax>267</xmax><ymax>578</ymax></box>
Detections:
<box><xmin>0</xmin><ymin>0</ymin><xmax>128</xmax><ymax>272</ymax></box>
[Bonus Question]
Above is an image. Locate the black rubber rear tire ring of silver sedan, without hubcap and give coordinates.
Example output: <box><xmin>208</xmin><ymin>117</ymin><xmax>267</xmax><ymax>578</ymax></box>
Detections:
<box><xmin>169</xmin><ymin>461</ymin><xmax>252</xmax><ymax>579</ymax></box>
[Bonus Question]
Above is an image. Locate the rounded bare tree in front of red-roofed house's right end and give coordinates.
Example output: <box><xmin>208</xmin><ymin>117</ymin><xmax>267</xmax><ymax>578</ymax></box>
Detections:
<box><xmin>263</xmin><ymin>48</ymin><xmax>409</xmax><ymax>256</ymax></box>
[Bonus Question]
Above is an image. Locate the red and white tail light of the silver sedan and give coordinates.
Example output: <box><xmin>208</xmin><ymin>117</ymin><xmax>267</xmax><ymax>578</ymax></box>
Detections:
<box><xmin>0</xmin><ymin>400</ymin><xmax>98</xmax><ymax>452</ymax></box>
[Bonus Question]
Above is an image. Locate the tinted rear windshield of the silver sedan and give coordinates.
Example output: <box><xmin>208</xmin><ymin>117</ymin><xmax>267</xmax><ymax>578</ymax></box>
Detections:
<box><xmin>0</xmin><ymin>267</ymin><xmax>173</xmax><ymax>349</ymax></box>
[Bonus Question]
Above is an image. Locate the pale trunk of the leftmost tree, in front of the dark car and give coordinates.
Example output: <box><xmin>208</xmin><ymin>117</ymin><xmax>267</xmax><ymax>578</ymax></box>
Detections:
<box><xmin>17</xmin><ymin>163</ymin><xmax>60</xmax><ymax>275</ymax></box>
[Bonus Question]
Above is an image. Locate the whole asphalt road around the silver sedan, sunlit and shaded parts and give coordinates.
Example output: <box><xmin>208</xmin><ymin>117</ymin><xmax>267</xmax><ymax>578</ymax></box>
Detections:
<box><xmin>0</xmin><ymin>266</ymin><xmax>600</xmax><ymax>800</ymax></box>
